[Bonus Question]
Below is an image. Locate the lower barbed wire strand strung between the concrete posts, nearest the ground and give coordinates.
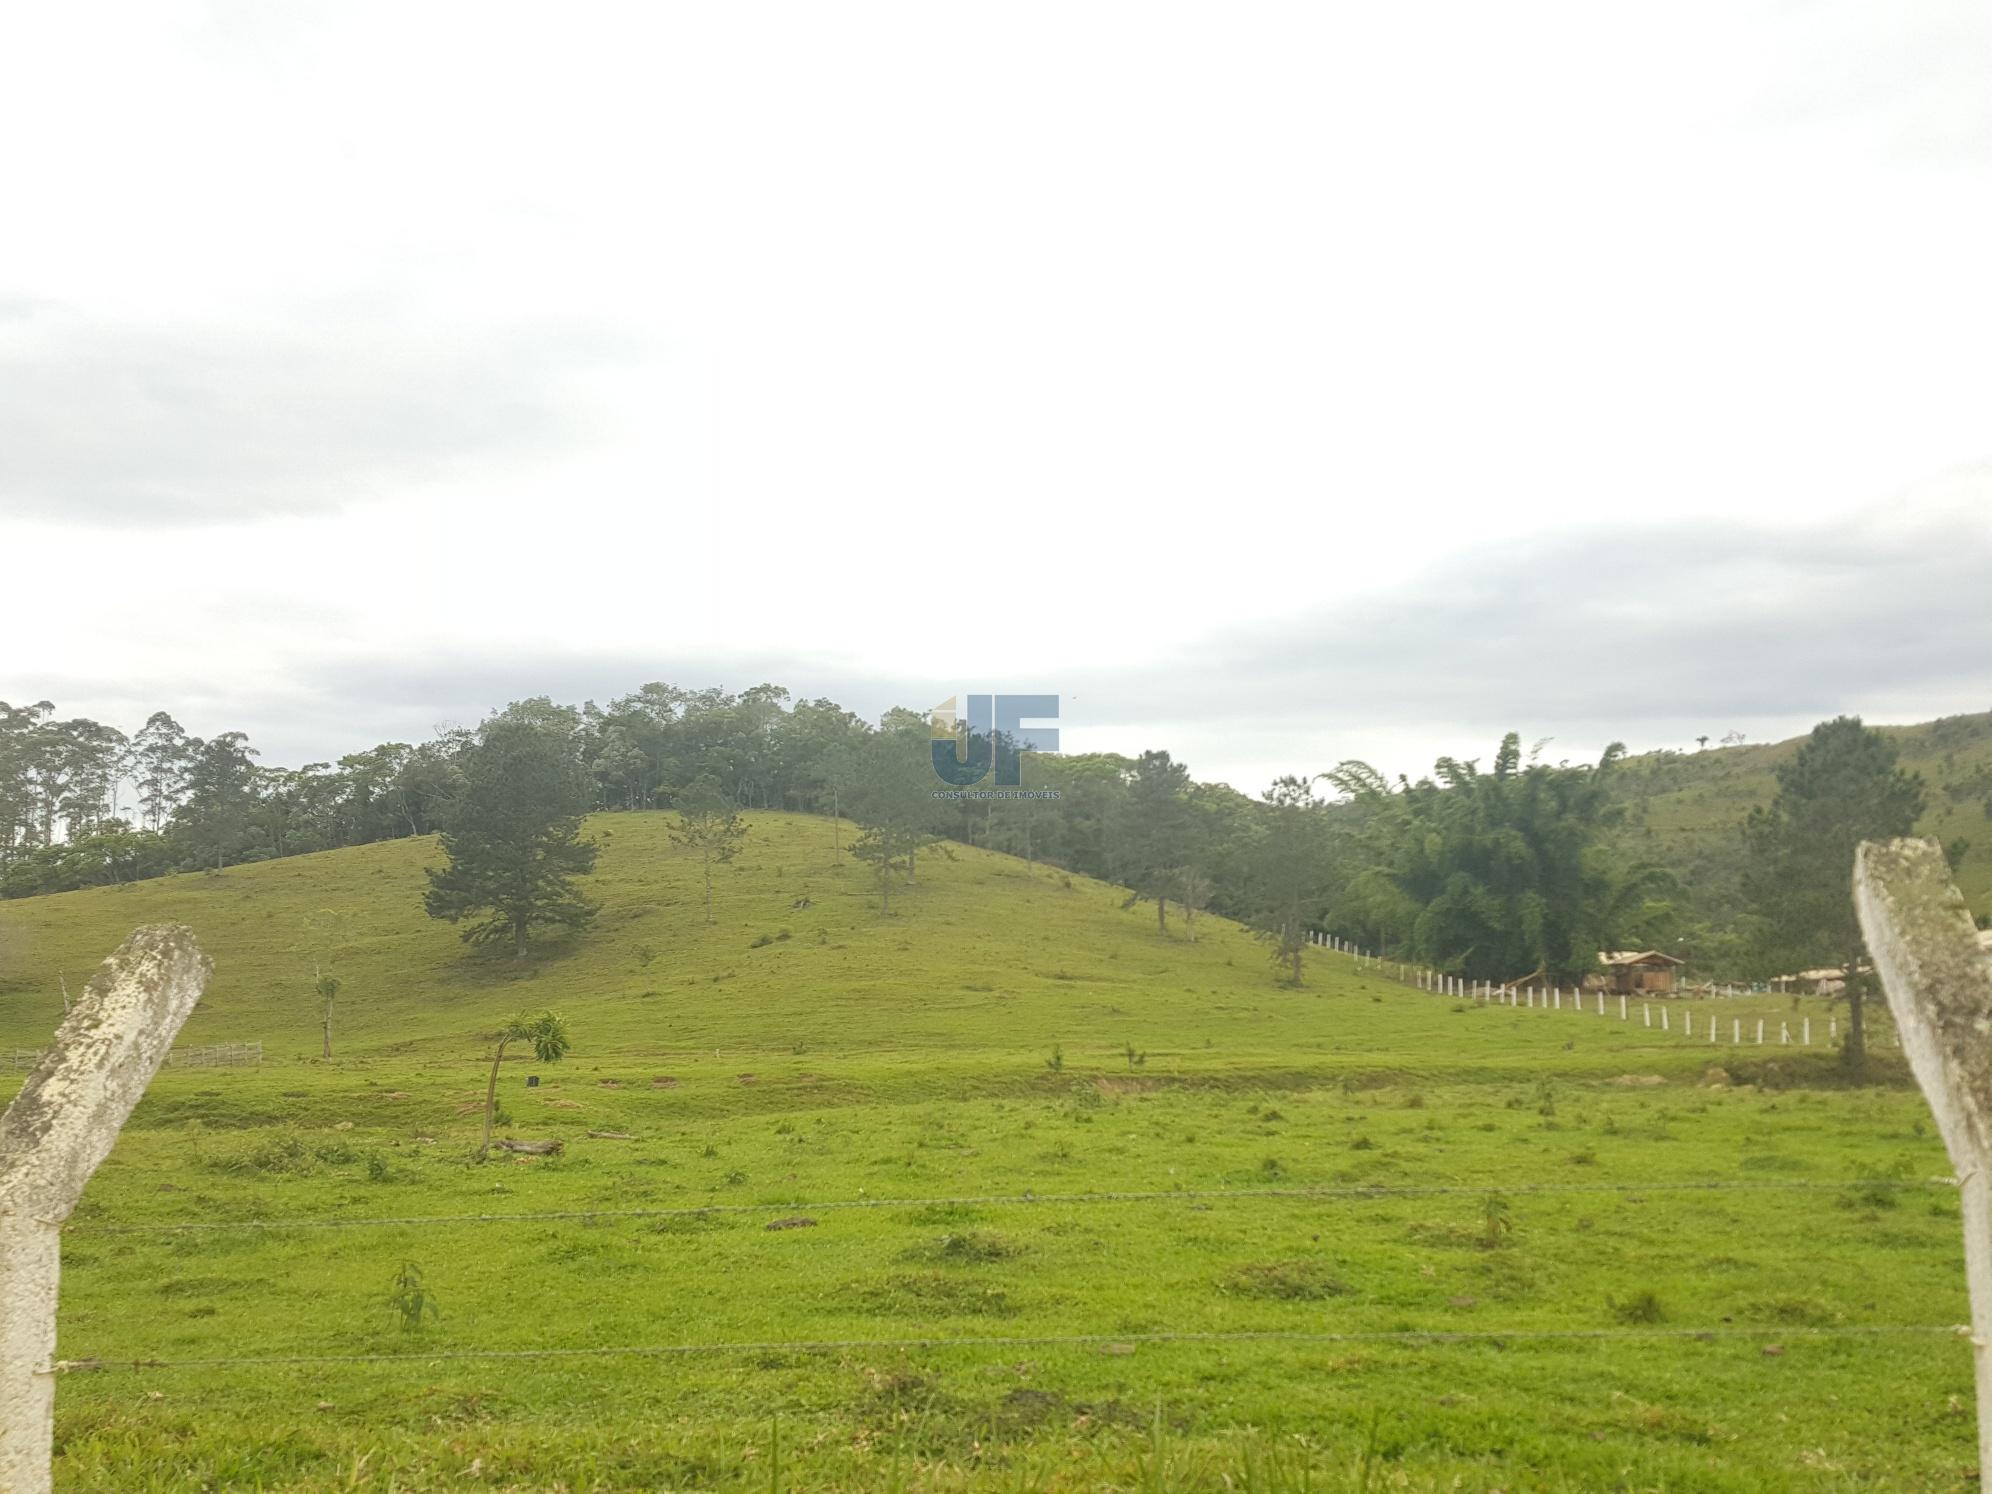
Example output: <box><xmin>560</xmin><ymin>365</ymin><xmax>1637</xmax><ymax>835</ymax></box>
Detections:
<box><xmin>50</xmin><ymin>1323</ymin><xmax>1970</xmax><ymax>1374</ymax></box>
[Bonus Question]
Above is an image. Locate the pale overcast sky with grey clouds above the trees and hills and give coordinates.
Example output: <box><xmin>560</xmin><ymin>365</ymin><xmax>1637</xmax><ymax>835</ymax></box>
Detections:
<box><xmin>0</xmin><ymin>0</ymin><xmax>1992</xmax><ymax>789</ymax></box>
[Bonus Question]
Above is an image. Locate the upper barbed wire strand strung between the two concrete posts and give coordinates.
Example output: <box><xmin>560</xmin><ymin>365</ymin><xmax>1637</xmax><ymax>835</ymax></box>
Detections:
<box><xmin>64</xmin><ymin>1177</ymin><xmax>1956</xmax><ymax>1235</ymax></box>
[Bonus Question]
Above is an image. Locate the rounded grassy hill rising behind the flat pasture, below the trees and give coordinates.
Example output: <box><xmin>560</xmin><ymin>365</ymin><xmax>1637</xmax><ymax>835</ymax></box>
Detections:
<box><xmin>0</xmin><ymin>811</ymin><xmax>1343</xmax><ymax>1064</ymax></box>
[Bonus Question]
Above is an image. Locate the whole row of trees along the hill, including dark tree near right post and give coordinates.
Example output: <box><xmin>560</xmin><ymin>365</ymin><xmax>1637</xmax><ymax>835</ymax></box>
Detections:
<box><xmin>0</xmin><ymin>683</ymin><xmax>1924</xmax><ymax>1067</ymax></box>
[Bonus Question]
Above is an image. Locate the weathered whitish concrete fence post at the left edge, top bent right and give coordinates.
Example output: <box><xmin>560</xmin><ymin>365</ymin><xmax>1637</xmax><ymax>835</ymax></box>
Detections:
<box><xmin>0</xmin><ymin>924</ymin><xmax>211</xmax><ymax>1494</ymax></box>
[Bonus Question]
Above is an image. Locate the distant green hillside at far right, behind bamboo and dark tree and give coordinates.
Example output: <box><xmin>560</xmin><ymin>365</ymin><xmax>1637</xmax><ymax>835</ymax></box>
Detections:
<box><xmin>1621</xmin><ymin>713</ymin><xmax>1992</xmax><ymax>928</ymax></box>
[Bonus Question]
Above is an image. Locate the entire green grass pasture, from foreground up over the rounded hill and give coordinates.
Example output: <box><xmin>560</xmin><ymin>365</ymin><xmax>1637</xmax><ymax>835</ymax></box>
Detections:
<box><xmin>0</xmin><ymin>815</ymin><xmax>1974</xmax><ymax>1490</ymax></box>
